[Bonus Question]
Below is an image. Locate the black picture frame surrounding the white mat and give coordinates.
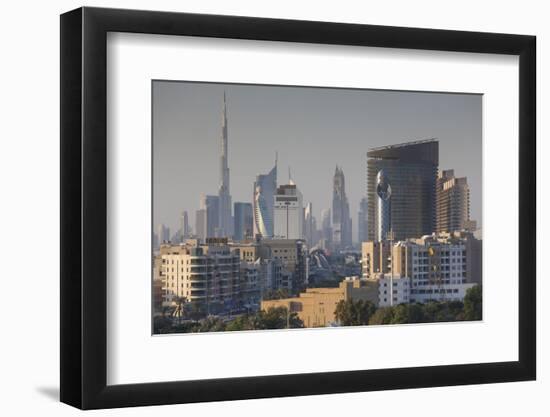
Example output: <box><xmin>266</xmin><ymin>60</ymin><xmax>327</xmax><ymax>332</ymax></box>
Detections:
<box><xmin>60</xmin><ymin>7</ymin><xmax>536</xmax><ymax>409</ymax></box>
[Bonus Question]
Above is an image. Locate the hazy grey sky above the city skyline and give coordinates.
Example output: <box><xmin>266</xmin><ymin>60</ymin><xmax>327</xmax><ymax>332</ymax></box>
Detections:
<box><xmin>153</xmin><ymin>81</ymin><xmax>482</xmax><ymax>239</ymax></box>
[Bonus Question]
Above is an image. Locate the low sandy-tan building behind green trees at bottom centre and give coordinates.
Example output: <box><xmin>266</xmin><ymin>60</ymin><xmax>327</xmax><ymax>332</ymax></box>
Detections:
<box><xmin>261</xmin><ymin>278</ymin><xmax>379</xmax><ymax>327</ymax></box>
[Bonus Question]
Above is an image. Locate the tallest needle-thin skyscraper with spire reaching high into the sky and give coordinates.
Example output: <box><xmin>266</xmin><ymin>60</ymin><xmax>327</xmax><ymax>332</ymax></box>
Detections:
<box><xmin>218</xmin><ymin>91</ymin><xmax>233</xmax><ymax>237</ymax></box>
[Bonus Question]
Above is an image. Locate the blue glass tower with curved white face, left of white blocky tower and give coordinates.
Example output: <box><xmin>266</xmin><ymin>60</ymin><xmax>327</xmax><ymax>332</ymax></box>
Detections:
<box><xmin>252</xmin><ymin>158</ymin><xmax>277</xmax><ymax>237</ymax></box>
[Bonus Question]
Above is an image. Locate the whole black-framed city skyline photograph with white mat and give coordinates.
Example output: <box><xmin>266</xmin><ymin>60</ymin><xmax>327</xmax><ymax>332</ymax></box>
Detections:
<box><xmin>61</xmin><ymin>7</ymin><xmax>536</xmax><ymax>409</ymax></box>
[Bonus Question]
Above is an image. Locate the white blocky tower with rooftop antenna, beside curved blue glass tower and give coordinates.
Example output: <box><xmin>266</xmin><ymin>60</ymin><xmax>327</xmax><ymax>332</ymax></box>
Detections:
<box><xmin>273</xmin><ymin>181</ymin><xmax>304</xmax><ymax>239</ymax></box>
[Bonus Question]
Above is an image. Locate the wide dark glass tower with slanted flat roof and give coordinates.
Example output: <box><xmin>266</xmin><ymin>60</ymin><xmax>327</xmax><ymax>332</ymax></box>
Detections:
<box><xmin>367</xmin><ymin>139</ymin><xmax>439</xmax><ymax>240</ymax></box>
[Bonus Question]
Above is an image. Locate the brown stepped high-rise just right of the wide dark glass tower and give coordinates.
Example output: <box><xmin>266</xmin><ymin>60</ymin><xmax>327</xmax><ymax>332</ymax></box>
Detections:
<box><xmin>436</xmin><ymin>169</ymin><xmax>471</xmax><ymax>232</ymax></box>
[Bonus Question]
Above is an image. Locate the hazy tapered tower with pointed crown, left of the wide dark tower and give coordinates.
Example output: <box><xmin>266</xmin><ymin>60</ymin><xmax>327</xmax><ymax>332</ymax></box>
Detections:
<box><xmin>332</xmin><ymin>165</ymin><xmax>351</xmax><ymax>248</ymax></box>
